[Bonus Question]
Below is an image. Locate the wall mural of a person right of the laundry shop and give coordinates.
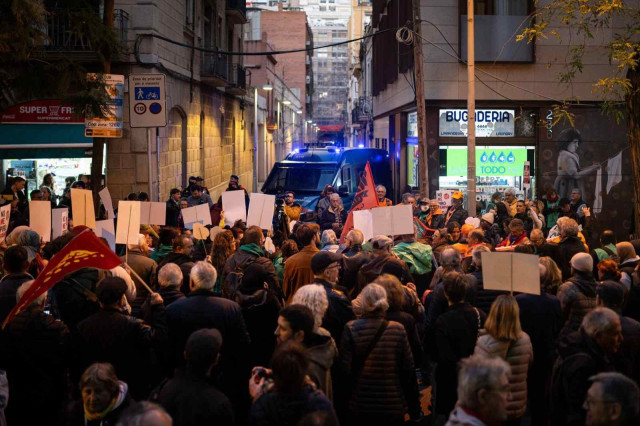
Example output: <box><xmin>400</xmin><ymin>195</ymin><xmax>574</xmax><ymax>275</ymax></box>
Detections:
<box><xmin>553</xmin><ymin>128</ymin><xmax>599</xmax><ymax>198</ymax></box>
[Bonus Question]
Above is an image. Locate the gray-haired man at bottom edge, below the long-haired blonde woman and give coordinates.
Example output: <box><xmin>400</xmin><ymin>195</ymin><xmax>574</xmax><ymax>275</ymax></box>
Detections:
<box><xmin>446</xmin><ymin>355</ymin><xmax>511</xmax><ymax>426</ymax></box>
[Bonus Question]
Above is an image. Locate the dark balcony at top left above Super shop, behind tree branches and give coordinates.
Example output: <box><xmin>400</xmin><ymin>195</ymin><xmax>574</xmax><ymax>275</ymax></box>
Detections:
<box><xmin>38</xmin><ymin>9</ymin><xmax>129</xmax><ymax>60</ymax></box>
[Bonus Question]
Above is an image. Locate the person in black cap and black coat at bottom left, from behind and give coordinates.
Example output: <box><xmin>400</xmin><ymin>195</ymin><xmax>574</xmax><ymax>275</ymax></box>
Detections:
<box><xmin>151</xmin><ymin>328</ymin><xmax>234</xmax><ymax>426</ymax></box>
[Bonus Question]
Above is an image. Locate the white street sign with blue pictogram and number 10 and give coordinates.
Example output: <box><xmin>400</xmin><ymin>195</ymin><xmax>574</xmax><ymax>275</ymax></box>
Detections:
<box><xmin>129</xmin><ymin>74</ymin><xmax>167</xmax><ymax>127</ymax></box>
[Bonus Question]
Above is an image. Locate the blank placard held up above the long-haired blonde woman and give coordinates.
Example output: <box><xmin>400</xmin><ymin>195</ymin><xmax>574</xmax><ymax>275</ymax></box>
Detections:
<box><xmin>482</xmin><ymin>252</ymin><xmax>540</xmax><ymax>295</ymax></box>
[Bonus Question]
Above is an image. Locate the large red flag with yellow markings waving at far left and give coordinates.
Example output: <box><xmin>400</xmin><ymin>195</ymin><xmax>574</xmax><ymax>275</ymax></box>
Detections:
<box><xmin>2</xmin><ymin>229</ymin><xmax>122</xmax><ymax>328</ymax></box>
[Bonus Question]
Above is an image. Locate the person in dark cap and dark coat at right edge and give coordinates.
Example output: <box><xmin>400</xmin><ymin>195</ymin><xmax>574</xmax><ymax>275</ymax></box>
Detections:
<box><xmin>596</xmin><ymin>281</ymin><xmax>640</xmax><ymax>382</ymax></box>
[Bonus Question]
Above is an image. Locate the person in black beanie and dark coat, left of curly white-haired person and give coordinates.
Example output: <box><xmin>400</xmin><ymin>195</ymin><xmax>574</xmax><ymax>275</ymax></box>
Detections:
<box><xmin>234</xmin><ymin>262</ymin><xmax>282</xmax><ymax>365</ymax></box>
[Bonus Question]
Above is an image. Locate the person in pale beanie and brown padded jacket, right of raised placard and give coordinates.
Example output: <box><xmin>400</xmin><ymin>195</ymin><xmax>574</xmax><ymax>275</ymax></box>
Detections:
<box><xmin>558</xmin><ymin>253</ymin><xmax>596</xmax><ymax>336</ymax></box>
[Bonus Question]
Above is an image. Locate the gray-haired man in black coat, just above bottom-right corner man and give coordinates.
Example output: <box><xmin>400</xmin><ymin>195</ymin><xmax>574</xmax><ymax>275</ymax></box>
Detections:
<box><xmin>551</xmin><ymin>307</ymin><xmax>622</xmax><ymax>426</ymax></box>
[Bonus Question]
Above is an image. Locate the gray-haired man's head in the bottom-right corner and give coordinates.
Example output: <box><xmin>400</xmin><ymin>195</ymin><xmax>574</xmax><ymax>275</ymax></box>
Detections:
<box><xmin>584</xmin><ymin>373</ymin><xmax>640</xmax><ymax>426</ymax></box>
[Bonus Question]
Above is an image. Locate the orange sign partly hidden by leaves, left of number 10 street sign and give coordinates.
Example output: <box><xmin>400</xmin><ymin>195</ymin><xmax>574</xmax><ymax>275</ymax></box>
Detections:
<box><xmin>84</xmin><ymin>73</ymin><xmax>124</xmax><ymax>138</ymax></box>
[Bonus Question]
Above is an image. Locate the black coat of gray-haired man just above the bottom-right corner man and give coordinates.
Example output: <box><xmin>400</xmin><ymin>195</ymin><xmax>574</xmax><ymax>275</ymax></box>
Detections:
<box><xmin>551</xmin><ymin>329</ymin><xmax>614</xmax><ymax>426</ymax></box>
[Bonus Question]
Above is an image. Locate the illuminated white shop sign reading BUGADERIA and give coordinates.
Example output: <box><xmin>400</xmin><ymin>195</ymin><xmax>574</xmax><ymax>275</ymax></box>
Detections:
<box><xmin>439</xmin><ymin>109</ymin><xmax>515</xmax><ymax>138</ymax></box>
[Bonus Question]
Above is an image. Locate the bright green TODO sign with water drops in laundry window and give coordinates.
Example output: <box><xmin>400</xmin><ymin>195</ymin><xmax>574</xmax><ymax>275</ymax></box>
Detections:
<box><xmin>447</xmin><ymin>148</ymin><xmax>527</xmax><ymax>176</ymax></box>
